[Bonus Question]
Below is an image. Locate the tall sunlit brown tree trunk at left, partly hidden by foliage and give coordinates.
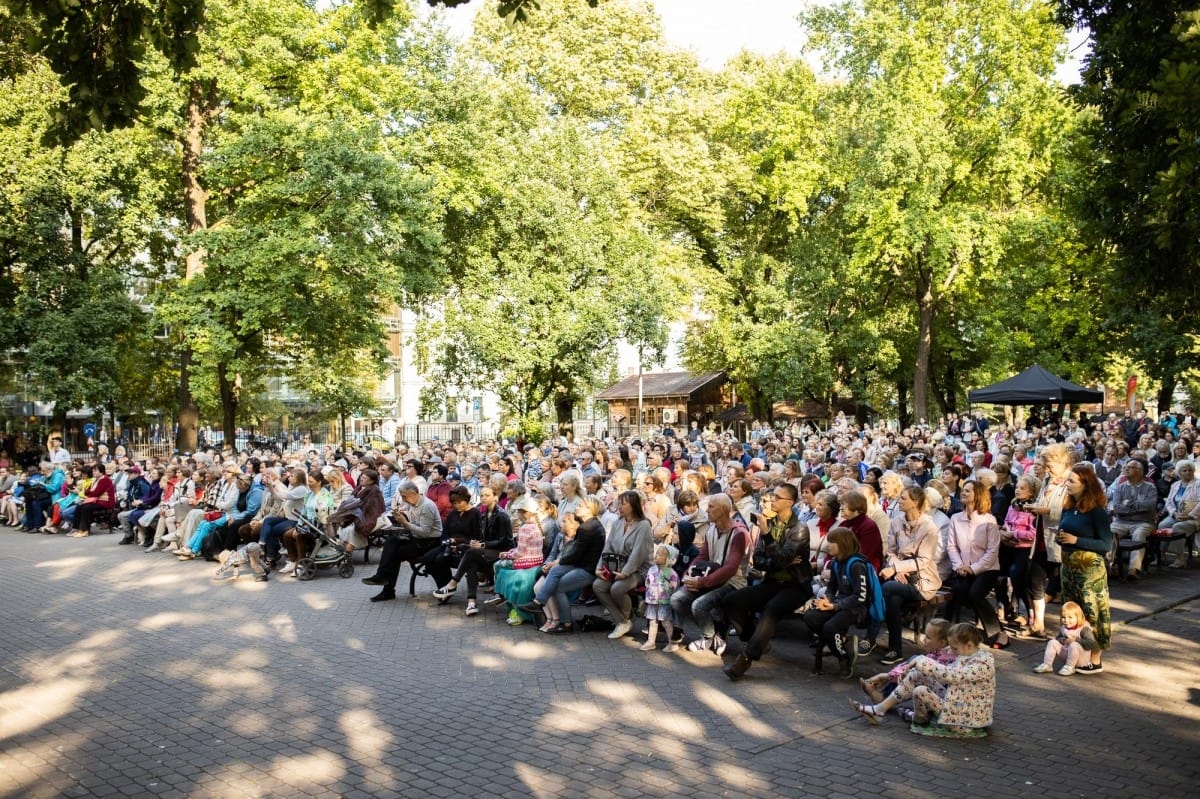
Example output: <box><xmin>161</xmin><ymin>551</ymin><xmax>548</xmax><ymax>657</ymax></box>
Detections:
<box><xmin>175</xmin><ymin>80</ymin><xmax>216</xmax><ymax>452</ymax></box>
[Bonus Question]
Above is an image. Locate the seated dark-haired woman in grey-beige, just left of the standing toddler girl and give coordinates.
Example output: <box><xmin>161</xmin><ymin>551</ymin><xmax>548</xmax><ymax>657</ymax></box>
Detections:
<box><xmin>592</xmin><ymin>491</ymin><xmax>654</xmax><ymax>638</ymax></box>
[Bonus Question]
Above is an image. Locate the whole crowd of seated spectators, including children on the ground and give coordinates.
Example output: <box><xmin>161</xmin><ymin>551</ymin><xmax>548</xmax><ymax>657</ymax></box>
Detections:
<box><xmin>0</xmin><ymin>409</ymin><xmax>1200</xmax><ymax>732</ymax></box>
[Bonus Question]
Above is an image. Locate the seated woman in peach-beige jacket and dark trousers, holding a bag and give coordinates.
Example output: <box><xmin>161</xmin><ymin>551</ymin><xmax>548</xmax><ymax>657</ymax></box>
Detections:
<box><xmin>880</xmin><ymin>486</ymin><xmax>942</xmax><ymax>666</ymax></box>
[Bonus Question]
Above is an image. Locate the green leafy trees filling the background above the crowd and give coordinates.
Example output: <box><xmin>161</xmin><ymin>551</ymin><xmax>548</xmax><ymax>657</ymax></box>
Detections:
<box><xmin>0</xmin><ymin>0</ymin><xmax>1200</xmax><ymax>441</ymax></box>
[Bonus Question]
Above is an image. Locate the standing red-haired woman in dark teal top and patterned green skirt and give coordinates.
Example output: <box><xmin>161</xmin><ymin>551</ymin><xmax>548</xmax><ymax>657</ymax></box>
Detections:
<box><xmin>1057</xmin><ymin>465</ymin><xmax>1112</xmax><ymax>674</ymax></box>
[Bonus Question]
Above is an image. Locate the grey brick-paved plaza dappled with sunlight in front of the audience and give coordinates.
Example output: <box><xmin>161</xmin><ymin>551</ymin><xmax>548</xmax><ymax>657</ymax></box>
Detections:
<box><xmin>0</xmin><ymin>529</ymin><xmax>1200</xmax><ymax>799</ymax></box>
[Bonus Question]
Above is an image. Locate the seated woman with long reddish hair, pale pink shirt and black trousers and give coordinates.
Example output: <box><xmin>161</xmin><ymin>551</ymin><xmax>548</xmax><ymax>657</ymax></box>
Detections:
<box><xmin>947</xmin><ymin>480</ymin><xmax>1009</xmax><ymax>649</ymax></box>
